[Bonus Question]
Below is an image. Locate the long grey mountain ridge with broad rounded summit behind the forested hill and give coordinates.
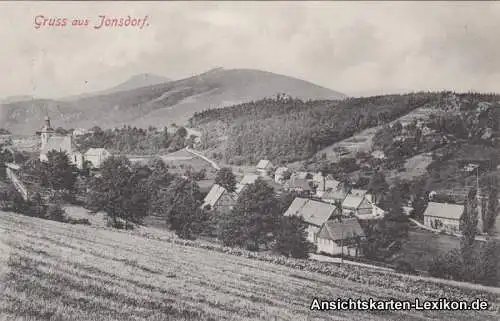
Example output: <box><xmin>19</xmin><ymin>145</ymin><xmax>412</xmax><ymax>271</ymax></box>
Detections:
<box><xmin>0</xmin><ymin>68</ymin><xmax>346</xmax><ymax>134</ymax></box>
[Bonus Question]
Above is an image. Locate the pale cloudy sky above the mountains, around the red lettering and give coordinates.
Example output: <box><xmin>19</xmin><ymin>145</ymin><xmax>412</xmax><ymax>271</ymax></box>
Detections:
<box><xmin>0</xmin><ymin>1</ymin><xmax>500</xmax><ymax>98</ymax></box>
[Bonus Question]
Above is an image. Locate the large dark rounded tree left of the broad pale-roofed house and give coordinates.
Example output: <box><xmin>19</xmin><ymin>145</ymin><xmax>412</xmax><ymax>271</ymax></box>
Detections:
<box><xmin>218</xmin><ymin>178</ymin><xmax>281</xmax><ymax>251</ymax></box>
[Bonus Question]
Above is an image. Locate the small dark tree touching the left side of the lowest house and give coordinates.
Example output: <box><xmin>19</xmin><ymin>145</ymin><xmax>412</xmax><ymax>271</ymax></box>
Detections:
<box><xmin>273</xmin><ymin>216</ymin><xmax>314</xmax><ymax>259</ymax></box>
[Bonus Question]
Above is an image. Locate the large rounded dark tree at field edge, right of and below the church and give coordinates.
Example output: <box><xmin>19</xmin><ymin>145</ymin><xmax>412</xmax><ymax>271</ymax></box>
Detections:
<box><xmin>87</xmin><ymin>156</ymin><xmax>148</xmax><ymax>224</ymax></box>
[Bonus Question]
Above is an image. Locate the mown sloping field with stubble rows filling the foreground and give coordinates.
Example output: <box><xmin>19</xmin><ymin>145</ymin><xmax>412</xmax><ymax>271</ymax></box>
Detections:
<box><xmin>0</xmin><ymin>212</ymin><xmax>499</xmax><ymax>321</ymax></box>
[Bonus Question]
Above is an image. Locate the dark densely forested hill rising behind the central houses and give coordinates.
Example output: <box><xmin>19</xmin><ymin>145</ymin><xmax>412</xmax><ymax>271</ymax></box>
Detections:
<box><xmin>190</xmin><ymin>92</ymin><xmax>446</xmax><ymax>164</ymax></box>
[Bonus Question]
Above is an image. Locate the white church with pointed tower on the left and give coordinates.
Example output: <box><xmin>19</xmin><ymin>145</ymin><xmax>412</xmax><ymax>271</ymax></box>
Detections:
<box><xmin>37</xmin><ymin>116</ymin><xmax>84</xmax><ymax>169</ymax></box>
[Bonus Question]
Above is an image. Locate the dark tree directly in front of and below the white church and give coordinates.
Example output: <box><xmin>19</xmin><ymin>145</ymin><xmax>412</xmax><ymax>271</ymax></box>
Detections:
<box><xmin>46</xmin><ymin>150</ymin><xmax>76</xmax><ymax>192</ymax></box>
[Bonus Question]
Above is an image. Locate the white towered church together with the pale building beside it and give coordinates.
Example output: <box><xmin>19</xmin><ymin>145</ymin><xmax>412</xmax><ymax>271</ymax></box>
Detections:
<box><xmin>37</xmin><ymin>116</ymin><xmax>111</xmax><ymax>169</ymax></box>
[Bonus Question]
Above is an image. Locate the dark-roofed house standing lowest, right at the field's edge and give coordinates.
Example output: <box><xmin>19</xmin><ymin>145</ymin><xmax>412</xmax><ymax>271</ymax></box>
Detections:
<box><xmin>316</xmin><ymin>218</ymin><xmax>365</xmax><ymax>256</ymax></box>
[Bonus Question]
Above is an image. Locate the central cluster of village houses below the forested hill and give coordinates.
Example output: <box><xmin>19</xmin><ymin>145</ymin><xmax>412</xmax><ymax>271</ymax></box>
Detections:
<box><xmin>202</xmin><ymin>160</ymin><xmax>385</xmax><ymax>256</ymax></box>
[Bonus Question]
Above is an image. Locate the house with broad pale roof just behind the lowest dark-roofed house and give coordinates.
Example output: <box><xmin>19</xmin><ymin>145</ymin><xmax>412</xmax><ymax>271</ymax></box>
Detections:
<box><xmin>284</xmin><ymin>197</ymin><xmax>339</xmax><ymax>244</ymax></box>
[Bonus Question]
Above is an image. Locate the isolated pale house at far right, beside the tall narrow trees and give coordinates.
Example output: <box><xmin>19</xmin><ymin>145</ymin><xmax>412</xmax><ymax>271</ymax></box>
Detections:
<box><xmin>424</xmin><ymin>202</ymin><xmax>464</xmax><ymax>233</ymax></box>
